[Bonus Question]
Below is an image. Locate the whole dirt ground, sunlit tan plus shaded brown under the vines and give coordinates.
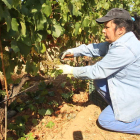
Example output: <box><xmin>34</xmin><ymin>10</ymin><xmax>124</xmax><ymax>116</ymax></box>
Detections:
<box><xmin>2</xmin><ymin>76</ymin><xmax>140</xmax><ymax>140</ymax></box>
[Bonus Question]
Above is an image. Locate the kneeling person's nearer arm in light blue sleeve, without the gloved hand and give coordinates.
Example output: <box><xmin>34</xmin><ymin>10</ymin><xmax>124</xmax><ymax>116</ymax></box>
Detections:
<box><xmin>73</xmin><ymin>45</ymin><xmax>135</xmax><ymax>79</ymax></box>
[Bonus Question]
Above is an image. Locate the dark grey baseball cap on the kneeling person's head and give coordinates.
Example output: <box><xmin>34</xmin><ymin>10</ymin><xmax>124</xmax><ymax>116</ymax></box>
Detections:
<box><xmin>96</xmin><ymin>8</ymin><xmax>132</xmax><ymax>23</ymax></box>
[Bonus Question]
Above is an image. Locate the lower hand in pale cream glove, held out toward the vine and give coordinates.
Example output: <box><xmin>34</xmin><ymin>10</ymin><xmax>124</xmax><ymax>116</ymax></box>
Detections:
<box><xmin>56</xmin><ymin>65</ymin><xmax>73</xmax><ymax>74</ymax></box>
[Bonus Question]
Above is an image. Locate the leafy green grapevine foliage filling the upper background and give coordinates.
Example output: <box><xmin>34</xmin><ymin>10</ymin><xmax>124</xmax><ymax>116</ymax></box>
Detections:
<box><xmin>0</xmin><ymin>0</ymin><xmax>140</xmax><ymax>139</ymax></box>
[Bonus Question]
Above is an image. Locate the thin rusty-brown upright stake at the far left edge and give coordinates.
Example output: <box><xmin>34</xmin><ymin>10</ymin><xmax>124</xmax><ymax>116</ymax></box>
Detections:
<box><xmin>0</xmin><ymin>28</ymin><xmax>9</xmax><ymax>140</ymax></box>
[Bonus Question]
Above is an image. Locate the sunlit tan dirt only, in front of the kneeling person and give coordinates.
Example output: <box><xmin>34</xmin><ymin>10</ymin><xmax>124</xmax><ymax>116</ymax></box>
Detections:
<box><xmin>28</xmin><ymin>104</ymin><xmax>140</xmax><ymax>140</ymax></box>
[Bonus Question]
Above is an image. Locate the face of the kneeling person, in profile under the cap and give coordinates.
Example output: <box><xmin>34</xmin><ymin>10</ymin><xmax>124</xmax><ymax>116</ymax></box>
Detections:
<box><xmin>102</xmin><ymin>20</ymin><xmax>120</xmax><ymax>43</ymax></box>
